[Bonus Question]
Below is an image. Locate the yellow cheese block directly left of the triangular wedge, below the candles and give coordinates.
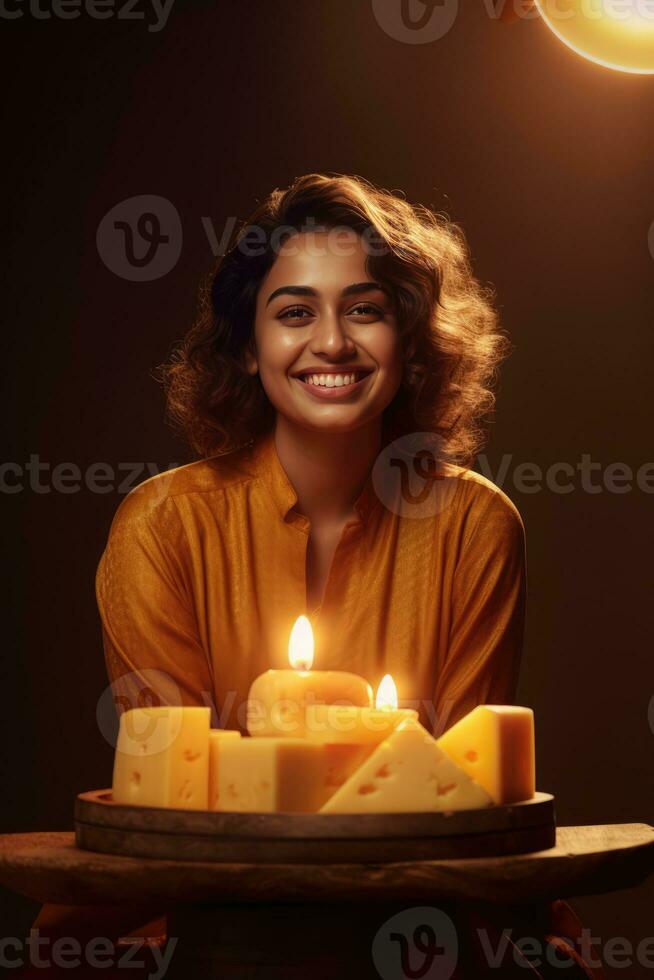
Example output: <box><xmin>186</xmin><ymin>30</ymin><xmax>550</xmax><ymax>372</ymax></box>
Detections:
<box><xmin>210</xmin><ymin>737</ymin><xmax>372</xmax><ymax>813</ymax></box>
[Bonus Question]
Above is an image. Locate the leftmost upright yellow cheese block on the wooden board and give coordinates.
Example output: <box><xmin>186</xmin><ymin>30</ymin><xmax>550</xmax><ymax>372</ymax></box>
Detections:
<box><xmin>112</xmin><ymin>707</ymin><xmax>211</xmax><ymax>810</ymax></box>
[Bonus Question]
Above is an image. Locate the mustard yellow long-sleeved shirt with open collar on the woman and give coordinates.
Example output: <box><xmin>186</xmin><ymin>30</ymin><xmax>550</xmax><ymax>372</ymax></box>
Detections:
<box><xmin>96</xmin><ymin>433</ymin><xmax>526</xmax><ymax>734</ymax></box>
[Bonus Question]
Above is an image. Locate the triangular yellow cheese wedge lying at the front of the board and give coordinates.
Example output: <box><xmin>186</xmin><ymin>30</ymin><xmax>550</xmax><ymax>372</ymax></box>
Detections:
<box><xmin>320</xmin><ymin>718</ymin><xmax>492</xmax><ymax>813</ymax></box>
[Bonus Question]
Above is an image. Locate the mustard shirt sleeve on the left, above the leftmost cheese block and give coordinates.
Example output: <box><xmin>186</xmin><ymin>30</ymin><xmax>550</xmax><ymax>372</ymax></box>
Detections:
<box><xmin>96</xmin><ymin>485</ymin><xmax>213</xmax><ymax>715</ymax></box>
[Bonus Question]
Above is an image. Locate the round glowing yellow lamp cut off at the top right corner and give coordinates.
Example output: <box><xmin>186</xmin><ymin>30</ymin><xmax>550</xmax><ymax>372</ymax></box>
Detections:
<box><xmin>535</xmin><ymin>0</ymin><xmax>654</xmax><ymax>75</ymax></box>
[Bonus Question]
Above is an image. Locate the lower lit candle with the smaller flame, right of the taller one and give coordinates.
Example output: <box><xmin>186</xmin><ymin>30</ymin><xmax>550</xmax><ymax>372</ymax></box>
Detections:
<box><xmin>305</xmin><ymin>674</ymin><xmax>418</xmax><ymax>745</ymax></box>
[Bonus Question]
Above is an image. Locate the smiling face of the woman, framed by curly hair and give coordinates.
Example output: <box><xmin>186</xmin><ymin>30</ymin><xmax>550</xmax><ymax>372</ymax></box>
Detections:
<box><xmin>246</xmin><ymin>229</ymin><xmax>402</xmax><ymax>431</ymax></box>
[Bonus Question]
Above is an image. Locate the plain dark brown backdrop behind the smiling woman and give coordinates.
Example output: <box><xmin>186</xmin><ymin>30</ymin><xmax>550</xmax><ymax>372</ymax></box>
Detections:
<box><xmin>0</xmin><ymin>0</ymin><xmax>654</xmax><ymax>976</ymax></box>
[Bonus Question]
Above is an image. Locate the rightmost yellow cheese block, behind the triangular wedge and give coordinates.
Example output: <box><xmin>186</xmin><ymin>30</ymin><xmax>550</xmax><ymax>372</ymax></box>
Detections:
<box><xmin>437</xmin><ymin>704</ymin><xmax>536</xmax><ymax>803</ymax></box>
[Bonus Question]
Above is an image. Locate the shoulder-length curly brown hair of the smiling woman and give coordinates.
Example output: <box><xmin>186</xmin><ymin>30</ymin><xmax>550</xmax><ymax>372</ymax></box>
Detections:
<box><xmin>158</xmin><ymin>173</ymin><xmax>511</xmax><ymax>466</ymax></box>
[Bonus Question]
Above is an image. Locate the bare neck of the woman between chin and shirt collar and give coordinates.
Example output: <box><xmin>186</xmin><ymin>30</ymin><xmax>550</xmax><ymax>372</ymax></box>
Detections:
<box><xmin>274</xmin><ymin>415</ymin><xmax>381</xmax><ymax>524</ymax></box>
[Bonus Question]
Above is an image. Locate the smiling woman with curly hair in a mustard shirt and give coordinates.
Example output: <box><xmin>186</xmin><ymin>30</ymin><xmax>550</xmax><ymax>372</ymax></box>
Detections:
<box><xmin>97</xmin><ymin>174</ymin><xmax>525</xmax><ymax>733</ymax></box>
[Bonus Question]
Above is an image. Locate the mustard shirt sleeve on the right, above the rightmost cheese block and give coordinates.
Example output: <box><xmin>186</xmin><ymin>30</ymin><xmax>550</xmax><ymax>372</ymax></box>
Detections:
<box><xmin>434</xmin><ymin>490</ymin><xmax>527</xmax><ymax>735</ymax></box>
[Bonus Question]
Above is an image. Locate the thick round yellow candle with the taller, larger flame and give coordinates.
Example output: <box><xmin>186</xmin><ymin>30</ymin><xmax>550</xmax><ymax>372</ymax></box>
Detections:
<box><xmin>247</xmin><ymin>616</ymin><xmax>372</xmax><ymax>741</ymax></box>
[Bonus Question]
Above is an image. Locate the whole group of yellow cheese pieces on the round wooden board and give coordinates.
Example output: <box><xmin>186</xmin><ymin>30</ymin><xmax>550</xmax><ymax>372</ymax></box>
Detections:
<box><xmin>113</xmin><ymin>705</ymin><xmax>535</xmax><ymax>813</ymax></box>
